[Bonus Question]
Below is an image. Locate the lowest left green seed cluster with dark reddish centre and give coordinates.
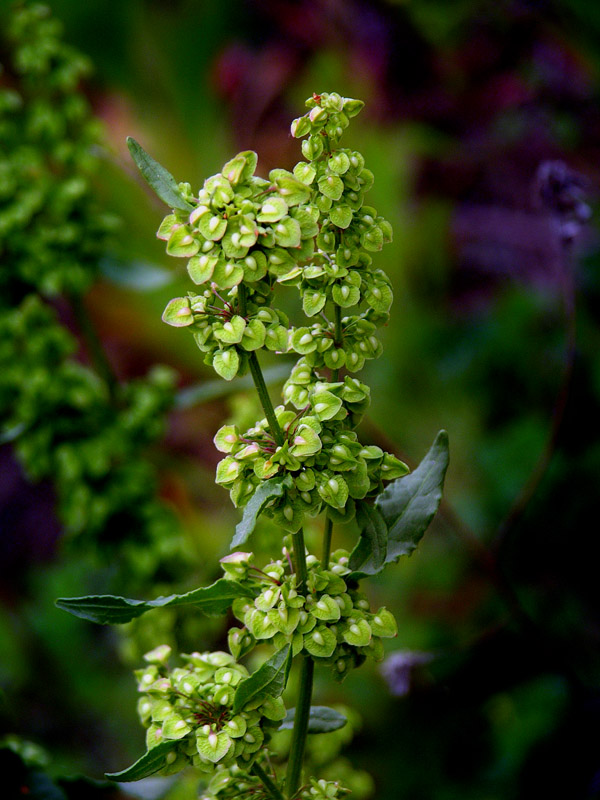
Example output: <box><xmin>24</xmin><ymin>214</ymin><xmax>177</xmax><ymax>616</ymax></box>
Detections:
<box><xmin>136</xmin><ymin>645</ymin><xmax>285</xmax><ymax>774</ymax></box>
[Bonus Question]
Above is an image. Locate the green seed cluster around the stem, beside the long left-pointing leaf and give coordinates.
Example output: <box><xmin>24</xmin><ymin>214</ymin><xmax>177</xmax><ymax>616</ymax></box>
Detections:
<box><xmin>221</xmin><ymin>550</ymin><xmax>397</xmax><ymax>680</ymax></box>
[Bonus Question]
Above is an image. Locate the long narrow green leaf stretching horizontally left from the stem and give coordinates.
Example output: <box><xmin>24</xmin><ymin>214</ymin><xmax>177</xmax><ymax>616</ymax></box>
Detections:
<box><xmin>56</xmin><ymin>578</ymin><xmax>254</xmax><ymax>625</ymax></box>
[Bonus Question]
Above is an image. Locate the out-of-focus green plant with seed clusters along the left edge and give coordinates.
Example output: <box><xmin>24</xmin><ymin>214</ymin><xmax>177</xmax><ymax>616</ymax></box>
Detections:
<box><xmin>0</xmin><ymin>4</ymin><xmax>188</xmax><ymax>581</ymax></box>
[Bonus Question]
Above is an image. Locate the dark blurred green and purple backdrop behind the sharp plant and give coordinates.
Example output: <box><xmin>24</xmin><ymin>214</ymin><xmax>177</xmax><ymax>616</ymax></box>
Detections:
<box><xmin>0</xmin><ymin>0</ymin><xmax>600</xmax><ymax>800</ymax></box>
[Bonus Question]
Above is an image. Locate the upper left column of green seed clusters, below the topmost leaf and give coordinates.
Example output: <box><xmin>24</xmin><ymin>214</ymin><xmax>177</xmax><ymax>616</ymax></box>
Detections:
<box><xmin>157</xmin><ymin>151</ymin><xmax>318</xmax><ymax>380</ymax></box>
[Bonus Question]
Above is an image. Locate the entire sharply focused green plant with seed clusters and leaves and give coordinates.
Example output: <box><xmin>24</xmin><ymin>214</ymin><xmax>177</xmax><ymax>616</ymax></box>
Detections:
<box><xmin>57</xmin><ymin>92</ymin><xmax>448</xmax><ymax>800</ymax></box>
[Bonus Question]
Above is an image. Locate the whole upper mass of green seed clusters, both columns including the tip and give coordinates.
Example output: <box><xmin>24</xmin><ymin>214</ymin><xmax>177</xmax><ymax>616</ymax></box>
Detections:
<box><xmin>158</xmin><ymin>94</ymin><xmax>392</xmax><ymax>388</ymax></box>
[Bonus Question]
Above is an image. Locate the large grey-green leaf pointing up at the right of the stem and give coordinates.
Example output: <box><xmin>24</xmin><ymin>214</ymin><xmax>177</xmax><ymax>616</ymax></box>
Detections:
<box><xmin>350</xmin><ymin>431</ymin><xmax>448</xmax><ymax>578</ymax></box>
